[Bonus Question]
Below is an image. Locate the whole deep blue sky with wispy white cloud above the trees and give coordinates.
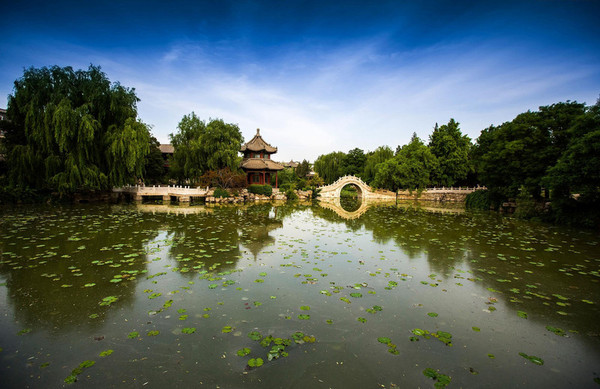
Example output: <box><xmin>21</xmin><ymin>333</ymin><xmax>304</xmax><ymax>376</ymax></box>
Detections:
<box><xmin>0</xmin><ymin>0</ymin><xmax>600</xmax><ymax>162</ymax></box>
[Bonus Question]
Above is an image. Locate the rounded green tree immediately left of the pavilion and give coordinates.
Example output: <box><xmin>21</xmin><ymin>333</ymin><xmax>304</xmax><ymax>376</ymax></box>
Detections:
<box><xmin>169</xmin><ymin>112</ymin><xmax>244</xmax><ymax>183</ymax></box>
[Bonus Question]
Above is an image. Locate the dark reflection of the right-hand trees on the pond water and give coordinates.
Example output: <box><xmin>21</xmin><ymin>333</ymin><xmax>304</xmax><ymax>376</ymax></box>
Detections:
<box><xmin>313</xmin><ymin>203</ymin><xmax>600</xmax><ymax>333</ymax></box>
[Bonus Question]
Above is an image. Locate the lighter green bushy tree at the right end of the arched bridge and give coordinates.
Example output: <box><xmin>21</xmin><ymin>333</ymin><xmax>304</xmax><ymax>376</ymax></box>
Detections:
<box><xmin>373</xmin><ymin>134</ymin><xmax>439</xmax><ymax>191</ymax></box>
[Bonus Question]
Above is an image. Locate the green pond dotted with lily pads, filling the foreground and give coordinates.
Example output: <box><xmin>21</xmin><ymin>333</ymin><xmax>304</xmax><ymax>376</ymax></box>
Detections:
<box><xmin>0</xmin><ymin>202</ymin><xmax>600</xmax><ymax>388</ymax></box>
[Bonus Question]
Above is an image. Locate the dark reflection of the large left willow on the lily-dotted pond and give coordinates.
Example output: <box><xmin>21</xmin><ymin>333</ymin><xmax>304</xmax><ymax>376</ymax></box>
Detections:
<box><xmin>0</xmin><ymin>207</ymin><xmax>157</xmax><ymax>332</ymax></box>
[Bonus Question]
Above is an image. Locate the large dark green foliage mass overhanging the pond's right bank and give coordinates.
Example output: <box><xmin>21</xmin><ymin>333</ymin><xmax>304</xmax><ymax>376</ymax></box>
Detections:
<box><xmin>473</xmin><ymin>101</ymin><xmax>600</xmax><ymax>227</ymax></box>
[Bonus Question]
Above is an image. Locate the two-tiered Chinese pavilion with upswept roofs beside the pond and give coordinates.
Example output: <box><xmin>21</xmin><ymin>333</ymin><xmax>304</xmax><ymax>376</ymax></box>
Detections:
<box><xmin>240</xmin><ymin>129</ymin><xmax>284</xmax><ymax>188</ymax></box>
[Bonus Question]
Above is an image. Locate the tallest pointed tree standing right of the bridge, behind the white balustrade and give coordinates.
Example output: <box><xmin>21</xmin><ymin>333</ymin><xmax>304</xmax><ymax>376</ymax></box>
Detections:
<box><xmin>429</xmin><ymin>119</ymin><xmax>471</xmax><ymax>186</ymax></box>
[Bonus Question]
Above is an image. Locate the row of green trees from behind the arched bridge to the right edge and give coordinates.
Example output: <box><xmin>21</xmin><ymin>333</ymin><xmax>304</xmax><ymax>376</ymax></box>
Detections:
<box><xmin>314</xmin><ymin>100</ymin><xmax>600</xmax><ymax>226</ymax></box>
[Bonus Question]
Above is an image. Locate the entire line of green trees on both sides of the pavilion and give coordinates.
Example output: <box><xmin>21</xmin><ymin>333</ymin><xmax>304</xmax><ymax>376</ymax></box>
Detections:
<box><xmin>0</xmin><ymin>65</ymin><xmax>600</xmax><ymax>226</ymax></box>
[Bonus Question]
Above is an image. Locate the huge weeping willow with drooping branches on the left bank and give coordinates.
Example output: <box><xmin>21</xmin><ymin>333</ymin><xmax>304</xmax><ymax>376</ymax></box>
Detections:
<box><xmin>6</xmin><ymin>65</ymin><xmax>150</xmax><ymax>195</ymax></box>
